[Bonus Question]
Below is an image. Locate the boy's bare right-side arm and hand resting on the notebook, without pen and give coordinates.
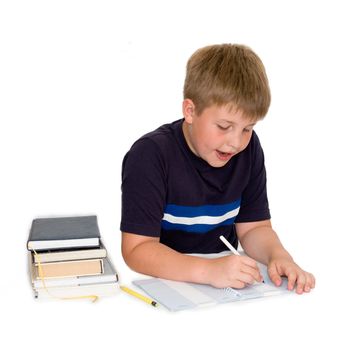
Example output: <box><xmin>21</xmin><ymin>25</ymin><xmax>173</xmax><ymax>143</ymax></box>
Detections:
<box><xmin>236</xmin><ymin>220</ymin><xmax>315</xmax><ymax>294</ymax></box>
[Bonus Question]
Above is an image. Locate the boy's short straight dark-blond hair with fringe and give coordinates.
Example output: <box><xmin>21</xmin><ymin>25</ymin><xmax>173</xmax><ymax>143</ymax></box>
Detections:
<box><xmin>184</xmin><ymin>44</ymin><xmax>271</xmax><ymax>121</ymax></box>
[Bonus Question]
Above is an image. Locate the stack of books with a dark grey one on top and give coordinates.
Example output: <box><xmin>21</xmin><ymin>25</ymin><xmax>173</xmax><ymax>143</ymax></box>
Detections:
<box><xmin>27</xmin><ymin>216</ymin><xmax>119</xmax><ymax>299</ymax></box>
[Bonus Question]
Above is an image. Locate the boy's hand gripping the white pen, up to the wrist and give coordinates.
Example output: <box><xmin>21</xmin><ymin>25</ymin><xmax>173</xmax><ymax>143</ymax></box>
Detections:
<box><xmin>207</xmin><ymin>255</ymin><xmax>263</xmax><ymax>288</ymax></box>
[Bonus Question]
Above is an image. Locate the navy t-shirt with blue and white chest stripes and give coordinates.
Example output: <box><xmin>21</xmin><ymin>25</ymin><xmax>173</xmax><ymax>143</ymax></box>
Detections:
<box><xmin>120</xmin><ymin>120</ymin><xmax>270</xmax><ymax>253</ymax></box>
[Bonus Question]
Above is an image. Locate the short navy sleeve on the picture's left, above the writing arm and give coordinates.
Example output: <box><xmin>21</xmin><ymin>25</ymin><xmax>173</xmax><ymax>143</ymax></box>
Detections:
<box><xmin>120</xmin><ymin>138</ymin><xmax>166</xmax><ymax>237</ymax></box>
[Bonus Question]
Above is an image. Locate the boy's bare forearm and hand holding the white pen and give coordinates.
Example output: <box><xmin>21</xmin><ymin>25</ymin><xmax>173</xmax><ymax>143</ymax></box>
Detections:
<box><xmin>122</xmin><ymin>232</ymin><xmax>262</xmax><ymax>288</ymax></box>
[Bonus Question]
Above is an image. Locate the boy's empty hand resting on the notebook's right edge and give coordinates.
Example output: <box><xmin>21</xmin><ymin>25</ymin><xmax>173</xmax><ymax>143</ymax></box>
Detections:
<box><xmin>268</xmin><ymin>258</ymin><xmax>315</xmax><ymax>294</ymax></box>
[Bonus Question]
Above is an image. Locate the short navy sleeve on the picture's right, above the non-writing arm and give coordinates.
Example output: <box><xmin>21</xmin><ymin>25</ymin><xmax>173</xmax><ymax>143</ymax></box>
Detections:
<box><xmin>235</xmin><ymin>134</ymin><xmax>271</xmax><ymax>222</ymax></box>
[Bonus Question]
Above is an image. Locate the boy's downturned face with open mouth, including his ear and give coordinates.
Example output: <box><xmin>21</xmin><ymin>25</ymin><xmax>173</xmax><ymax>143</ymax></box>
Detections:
<box><xmin>183</xmin><ymin>99</ymin><xmax>255</xmax><ymax>168</ymax></box>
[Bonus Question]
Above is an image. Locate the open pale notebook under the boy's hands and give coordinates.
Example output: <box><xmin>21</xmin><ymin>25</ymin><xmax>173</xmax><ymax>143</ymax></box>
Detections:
<box><xmin>133</xmin><ymin>254</ymin><xmax>289</xmax><ymax>311</ymax></box>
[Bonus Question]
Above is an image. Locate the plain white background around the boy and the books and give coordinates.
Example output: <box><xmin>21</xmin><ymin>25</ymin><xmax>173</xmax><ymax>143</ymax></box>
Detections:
<box><xmin>0</xmin><ymin>0</ymin><xmax>350</xmax><ymax>349</ymax></box>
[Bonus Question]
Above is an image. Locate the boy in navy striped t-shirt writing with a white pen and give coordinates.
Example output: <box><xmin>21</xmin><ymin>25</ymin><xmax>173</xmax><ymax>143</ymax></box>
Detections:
<box><xmin>121</xmin><ymin>44</ymin><xmax>315</xmax><ymax>294</ymax></box>
